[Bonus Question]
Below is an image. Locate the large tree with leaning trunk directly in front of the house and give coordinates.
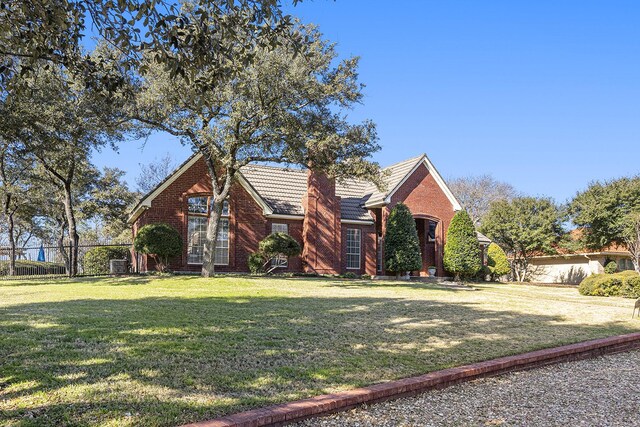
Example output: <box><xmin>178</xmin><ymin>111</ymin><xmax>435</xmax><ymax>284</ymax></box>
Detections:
<box><xmin>132</xmin><ymin>20</ymin><xmax>380</xmax><ymax>276</ymax></box>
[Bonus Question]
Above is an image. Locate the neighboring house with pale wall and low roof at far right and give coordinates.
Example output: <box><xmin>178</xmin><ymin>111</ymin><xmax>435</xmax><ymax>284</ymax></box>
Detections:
<box><xmin>529</xmin><ymin>248</ymin><xmax>633</xmax><ymax>285</ymax></box>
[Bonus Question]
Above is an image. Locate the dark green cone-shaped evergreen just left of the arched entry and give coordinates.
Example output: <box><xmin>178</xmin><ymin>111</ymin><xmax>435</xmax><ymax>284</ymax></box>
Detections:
<box><xmin>384</xmin><ymin>203</ymin><xmax>422</xmax><ymax>275</ymax></box>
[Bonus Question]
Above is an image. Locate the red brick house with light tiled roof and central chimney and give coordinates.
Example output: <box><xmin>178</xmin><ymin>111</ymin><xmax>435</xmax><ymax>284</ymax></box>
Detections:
<box><xmin>129</xmin><ymin>154</ymin><xmax>461</xmax><ymax>276</ymax></box>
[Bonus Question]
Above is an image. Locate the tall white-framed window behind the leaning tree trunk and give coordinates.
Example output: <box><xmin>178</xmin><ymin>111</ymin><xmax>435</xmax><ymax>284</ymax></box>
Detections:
<box><xmin>187</xmin><ymin>196</ymin><xmax>229</xmax><ymax>265</ymax></box>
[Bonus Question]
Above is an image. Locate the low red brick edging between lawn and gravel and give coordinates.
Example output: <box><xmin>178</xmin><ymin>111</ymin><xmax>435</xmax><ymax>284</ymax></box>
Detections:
<box><xmin>183</xmin><ymin>332</ymin><xmax>640</xmax><ymax>427</ymax></box>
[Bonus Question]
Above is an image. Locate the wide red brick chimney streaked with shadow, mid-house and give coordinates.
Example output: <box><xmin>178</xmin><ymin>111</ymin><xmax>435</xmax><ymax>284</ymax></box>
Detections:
<box><xmin>302</xmin><ymin>169</ymin><xmax>342</xmax><ymax>274</ymax></box>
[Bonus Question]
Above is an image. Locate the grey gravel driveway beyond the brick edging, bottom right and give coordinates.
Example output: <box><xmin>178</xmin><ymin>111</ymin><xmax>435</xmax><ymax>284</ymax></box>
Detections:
<box><xmin>296</xmin><ymin>351</ymin><xmax>640</xmax><ymax>427</ymax></box>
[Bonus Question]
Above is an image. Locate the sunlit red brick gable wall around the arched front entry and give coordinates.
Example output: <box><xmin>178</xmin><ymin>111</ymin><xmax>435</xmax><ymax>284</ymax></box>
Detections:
<box><xmin>383</xmin><ymin>164</ymin><xmax>455</xmax><ymax>276</ymax></box>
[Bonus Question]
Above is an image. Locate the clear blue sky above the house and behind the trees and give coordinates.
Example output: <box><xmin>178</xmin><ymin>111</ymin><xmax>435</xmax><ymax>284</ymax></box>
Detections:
<box><xmin>95</xmin><ymin>0</ymin><xmax>640</xmax><ymax>202</ymax></box>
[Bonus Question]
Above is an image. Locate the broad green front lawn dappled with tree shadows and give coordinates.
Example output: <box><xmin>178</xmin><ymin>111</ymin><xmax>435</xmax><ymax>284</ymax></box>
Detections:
<box><xmin>0</xmin><ymin>277</ymin><xmax>640</xmax><ymax>426</ymax></box>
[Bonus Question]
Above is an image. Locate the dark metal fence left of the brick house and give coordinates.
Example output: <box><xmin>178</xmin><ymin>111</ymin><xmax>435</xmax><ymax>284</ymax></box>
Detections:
<box><xmin>0</xmin><ymin>242</ymin><xmax>132</xmax><ymax>280</ymax></box>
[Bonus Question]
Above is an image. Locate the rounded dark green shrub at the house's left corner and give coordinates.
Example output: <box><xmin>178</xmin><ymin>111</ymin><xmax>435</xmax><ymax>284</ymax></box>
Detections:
<box><xmin>133</xmin><ymin>223</ymin><xmax>182</xmax><ymax>271</ymax></box>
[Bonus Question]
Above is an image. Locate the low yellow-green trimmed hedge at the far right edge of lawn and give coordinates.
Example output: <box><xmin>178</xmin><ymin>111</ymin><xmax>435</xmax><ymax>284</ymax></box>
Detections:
<box><xmin>578</xmin><ymin>270</ymin><xmax>640</xmax><ymax>298</ymax></box>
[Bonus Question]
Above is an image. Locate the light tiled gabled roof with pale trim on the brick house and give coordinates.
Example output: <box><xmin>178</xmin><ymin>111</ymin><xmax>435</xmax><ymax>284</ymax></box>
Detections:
<box><xmin>129</xmin><ymin>154</ymin><xmax>461</xmax><ymax>223</ymax></box>
